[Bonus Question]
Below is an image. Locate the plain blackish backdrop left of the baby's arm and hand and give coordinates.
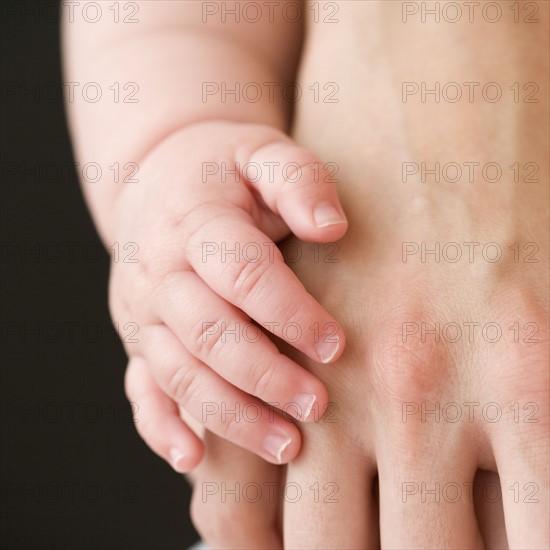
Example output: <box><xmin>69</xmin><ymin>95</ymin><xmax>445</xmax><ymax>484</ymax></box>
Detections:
<box><xmin>0</xmin><ymin>1</ymin><xmax>198</xmax><ymax>550</ymax></box>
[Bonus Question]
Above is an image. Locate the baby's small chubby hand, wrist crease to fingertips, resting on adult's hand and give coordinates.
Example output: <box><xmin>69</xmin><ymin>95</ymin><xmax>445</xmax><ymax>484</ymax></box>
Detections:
<box><xmin>110</xmin><ymin>122</ymin><xmax>347</xmax><ymax>471</ymax></box>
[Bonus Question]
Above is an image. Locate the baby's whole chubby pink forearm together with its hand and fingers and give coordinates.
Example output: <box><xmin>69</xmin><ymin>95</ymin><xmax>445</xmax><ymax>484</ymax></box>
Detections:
<box><xmin>63</xmin><ymin>1</ymin><xmax>347</xmax><ymax>471</ymax></box>
